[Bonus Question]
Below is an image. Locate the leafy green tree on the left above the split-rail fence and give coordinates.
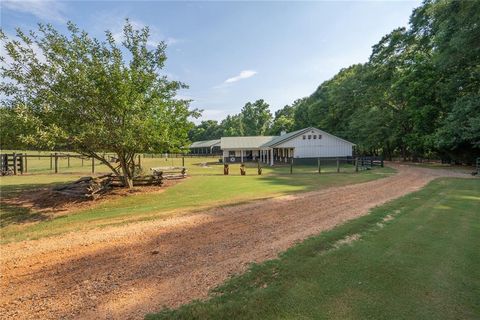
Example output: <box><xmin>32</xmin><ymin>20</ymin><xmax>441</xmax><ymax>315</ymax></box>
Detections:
<box><xmin>0</xmin><ymin>20</ymin><xmax>198</xmax><ymax>187</ymax></box>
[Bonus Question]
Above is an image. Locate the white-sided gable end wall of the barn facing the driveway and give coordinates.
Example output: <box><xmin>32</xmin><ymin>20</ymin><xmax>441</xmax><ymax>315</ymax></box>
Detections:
<box><xmin>275</xmin><ymin>130</ymin><xmax>353</xmax><ymax>158</ymax></box>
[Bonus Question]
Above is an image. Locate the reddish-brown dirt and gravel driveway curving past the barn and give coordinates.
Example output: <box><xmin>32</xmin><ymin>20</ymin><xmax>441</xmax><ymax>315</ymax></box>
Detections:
<box><xmin>0</xmin><ymin>165</ymin><xmax>472</xmax><ymax>319</ymax></box>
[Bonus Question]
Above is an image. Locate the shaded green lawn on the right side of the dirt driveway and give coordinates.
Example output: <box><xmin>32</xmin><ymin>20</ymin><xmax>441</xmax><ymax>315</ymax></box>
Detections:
<box><xmin>146</xmin><ymin>179</ymin><xmax>480</xmax><ymax>320</ymax></box>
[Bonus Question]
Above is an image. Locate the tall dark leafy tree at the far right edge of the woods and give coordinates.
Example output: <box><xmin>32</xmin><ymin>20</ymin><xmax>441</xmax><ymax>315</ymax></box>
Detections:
<box><xmin>411</xmin><ymin>0</ymin><xmax>480</xmax><ymax>161</ymax></box>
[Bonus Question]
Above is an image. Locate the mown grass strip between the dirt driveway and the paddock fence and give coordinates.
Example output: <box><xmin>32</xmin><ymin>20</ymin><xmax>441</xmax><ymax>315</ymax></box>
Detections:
<box><xmin>0</xmin><ymin>165</ymin><xmax>395</xmax><ymax>243</ymax></box>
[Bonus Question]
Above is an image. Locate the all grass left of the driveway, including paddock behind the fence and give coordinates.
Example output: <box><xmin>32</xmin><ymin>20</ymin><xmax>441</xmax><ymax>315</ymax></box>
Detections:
<box><xmin>0</xmin><ymin>158</ymin><xmax>394</xmax><ymax>243</ymax></box>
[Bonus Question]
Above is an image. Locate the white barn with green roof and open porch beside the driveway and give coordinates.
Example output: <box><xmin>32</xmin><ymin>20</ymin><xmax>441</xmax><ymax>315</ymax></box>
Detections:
<box><xmin>220</xmin><ymin>127</ymin><xmax>355</xmax><ymax>165</ymax></box>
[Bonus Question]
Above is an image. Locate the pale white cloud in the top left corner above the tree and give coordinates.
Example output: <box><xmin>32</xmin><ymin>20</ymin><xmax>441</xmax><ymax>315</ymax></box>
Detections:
<box><xmin>2</xmin><ymin>0</ymin><xmax>67</xmax><ymax>23</ymax></box>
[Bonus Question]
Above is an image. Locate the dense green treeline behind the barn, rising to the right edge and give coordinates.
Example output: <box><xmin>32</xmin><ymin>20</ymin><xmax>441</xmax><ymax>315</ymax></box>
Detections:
<box><xmin>189</xmin><ymin>0</ymin><xmax>480</xmax><ymax>162</ymax></box>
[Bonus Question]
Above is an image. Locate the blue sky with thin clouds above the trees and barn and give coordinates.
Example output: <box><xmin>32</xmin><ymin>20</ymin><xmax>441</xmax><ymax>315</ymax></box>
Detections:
<box><xmin>1</xmin><ymin>0</ymin><xmax>420</xmax><ymax>120</ymax></box>
